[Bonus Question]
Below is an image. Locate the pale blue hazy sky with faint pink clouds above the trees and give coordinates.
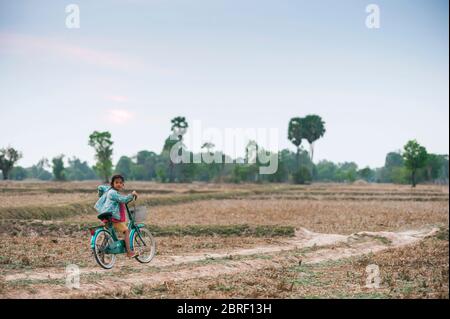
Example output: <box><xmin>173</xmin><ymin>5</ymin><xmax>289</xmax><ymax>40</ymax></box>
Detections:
<box><xmin>0</xmin><ymin>0</ymin><xmax>449</xmax><ymax>167</ymax></box>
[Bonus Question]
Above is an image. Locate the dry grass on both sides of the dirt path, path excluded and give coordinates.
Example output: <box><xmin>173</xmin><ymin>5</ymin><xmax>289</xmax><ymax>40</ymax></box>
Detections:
<box><xmin>0</xmin><ymin>181</ymin><xmax>449</xmax><ymax>298</ymax></box>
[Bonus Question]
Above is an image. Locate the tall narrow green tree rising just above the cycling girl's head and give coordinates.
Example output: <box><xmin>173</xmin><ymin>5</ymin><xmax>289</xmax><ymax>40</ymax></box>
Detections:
<box><xmin>89</xmin><ymin>131</ymin><xmax>114</xmax><ymax>182</ymax></box>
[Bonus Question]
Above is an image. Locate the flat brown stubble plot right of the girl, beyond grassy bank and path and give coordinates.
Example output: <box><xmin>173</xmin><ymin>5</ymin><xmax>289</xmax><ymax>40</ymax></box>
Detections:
<box><xmin>148</xmin><ymin>200</ymin><xmax>448</xmax><ymax>234</ymax></box>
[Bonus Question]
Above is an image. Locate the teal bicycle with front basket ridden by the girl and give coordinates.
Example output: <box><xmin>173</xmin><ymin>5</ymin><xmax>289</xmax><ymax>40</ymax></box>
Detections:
<box><xmin>90</xmin><ymin>197</ymin><xmax>156</xmax><ymax>269</ymax></box>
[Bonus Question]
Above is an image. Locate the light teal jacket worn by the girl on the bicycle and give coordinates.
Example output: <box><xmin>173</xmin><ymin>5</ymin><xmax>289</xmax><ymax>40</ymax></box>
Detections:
<box><xmin>94</xmin><ymin>185</ymin><xmax>133</xmax><ymax>219</ymax></box>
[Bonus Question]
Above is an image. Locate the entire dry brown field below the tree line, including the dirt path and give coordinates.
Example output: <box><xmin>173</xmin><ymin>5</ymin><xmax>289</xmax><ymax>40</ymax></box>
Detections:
<box><xmin>0</xmin><ymin>182</ymin><xmax>449</xmax><ymax>298</ymax></box>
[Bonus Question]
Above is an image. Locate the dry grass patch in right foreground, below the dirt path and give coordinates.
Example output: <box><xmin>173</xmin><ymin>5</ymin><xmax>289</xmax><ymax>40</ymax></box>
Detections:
<box><xmin>109</xmin><ymin>234</ymin><xmax>449</xmax><ymax>299</ymax></box>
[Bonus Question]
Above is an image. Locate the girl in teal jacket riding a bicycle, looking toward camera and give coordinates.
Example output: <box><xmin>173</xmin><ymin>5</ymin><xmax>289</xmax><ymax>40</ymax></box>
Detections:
<box><xmin>95</xmin><ymin>175</ymin><xmax>137</xmax><ymax>258</ymax></box>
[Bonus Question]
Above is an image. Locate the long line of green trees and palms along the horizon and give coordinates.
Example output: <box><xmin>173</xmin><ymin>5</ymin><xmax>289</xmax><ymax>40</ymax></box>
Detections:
<box><xmin>0</xmin><ymin>115</ymin><xmax>449</xmax><ymax>186</ymax></box>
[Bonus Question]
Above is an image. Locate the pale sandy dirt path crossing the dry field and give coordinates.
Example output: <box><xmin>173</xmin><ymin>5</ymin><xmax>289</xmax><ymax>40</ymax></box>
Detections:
<box><xmin>0</xmin><ymin>228</ymin><xmax>438</xmax><ymax>298</ymax></box>
